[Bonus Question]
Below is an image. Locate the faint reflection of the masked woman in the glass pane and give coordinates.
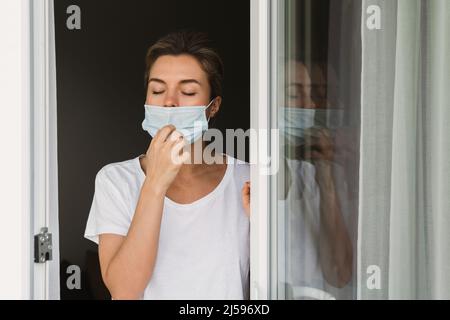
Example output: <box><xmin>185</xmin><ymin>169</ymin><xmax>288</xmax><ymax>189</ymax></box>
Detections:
<box><xmin>280</xmin><ymin>61</ymin><xmax>353</xmax><ymax>296</ymax></box>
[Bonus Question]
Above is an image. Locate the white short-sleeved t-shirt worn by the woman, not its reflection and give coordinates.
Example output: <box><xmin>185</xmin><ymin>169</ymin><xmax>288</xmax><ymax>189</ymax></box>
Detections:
<box><xmin>84</xmin><ymin>156</ymin><xmax>250</xmax><ymax>300</ymax></box>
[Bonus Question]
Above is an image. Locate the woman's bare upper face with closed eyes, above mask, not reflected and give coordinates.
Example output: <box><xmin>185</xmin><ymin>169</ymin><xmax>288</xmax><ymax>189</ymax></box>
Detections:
<box><xmin>146</xmin><ymin>55</ymin><xmax>211</xmax><ymax>107</ymax></box>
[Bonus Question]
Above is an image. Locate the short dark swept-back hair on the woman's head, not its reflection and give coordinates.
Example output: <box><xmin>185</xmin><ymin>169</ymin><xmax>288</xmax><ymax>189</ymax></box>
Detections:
<box><xmin>145</xmin><ymin>31</ymin><xmax>224</xmax><ymax>99</ymax></box>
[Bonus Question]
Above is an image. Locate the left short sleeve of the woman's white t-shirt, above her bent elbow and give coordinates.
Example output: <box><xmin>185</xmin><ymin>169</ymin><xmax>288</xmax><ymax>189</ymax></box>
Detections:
<box><xmin>84</xmin><ymin>168</ymin><xmax>131</xmax><ymax>244</ymax></box>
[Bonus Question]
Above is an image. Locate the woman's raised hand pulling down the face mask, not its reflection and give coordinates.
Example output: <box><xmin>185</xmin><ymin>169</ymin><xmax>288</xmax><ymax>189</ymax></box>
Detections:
<box><xmin>144</xmin><ymin>125</ymin><xmax>189</xmax><ymax>194</ymax></box>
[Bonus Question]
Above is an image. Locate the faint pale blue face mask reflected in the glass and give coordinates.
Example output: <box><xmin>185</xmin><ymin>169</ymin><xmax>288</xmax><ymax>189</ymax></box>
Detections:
<box><xmin>278</xmin><ymin>107</ymin><xmax>344</xmax><ymax>145</ymax></box>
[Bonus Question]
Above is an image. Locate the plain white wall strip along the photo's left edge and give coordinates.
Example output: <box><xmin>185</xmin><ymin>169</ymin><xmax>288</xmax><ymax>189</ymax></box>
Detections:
<box><xmin>0</xmin><ymin>0</ymin><xmax>32</xmax><ymax>299</ymax></box>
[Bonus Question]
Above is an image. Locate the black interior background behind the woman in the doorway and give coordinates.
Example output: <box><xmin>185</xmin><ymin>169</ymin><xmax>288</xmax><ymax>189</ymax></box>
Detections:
<box><xmin>55</xmin><ymin>0</ymin><xmax>250</xmax><ymax>299</ymax></box>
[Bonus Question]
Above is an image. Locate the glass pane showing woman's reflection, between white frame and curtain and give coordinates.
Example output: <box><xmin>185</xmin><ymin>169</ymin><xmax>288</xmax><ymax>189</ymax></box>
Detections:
<box><xmin>272</xmin><ymin>0</ymin><xmax>361</xmax><ymax>299</ymax></box>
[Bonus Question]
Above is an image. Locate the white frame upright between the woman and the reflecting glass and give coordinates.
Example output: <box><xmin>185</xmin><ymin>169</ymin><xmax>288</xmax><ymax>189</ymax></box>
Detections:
<box><xmin>250</xmin><ymin>0</ymin><xmax>270</xmax><ymax>300</ymax></box>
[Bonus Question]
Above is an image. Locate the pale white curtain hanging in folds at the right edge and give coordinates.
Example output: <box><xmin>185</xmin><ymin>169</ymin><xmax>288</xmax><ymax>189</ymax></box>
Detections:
<box><xmin>358</xmin><ymin>0</ymin><xmax>450</xmax><ymax>299</ymax></box>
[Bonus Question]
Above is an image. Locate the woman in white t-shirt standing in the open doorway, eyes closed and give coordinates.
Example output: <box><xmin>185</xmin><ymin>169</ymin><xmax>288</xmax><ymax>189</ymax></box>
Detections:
<box><xmin>85</xmin><ymin>32</ymin><xmax>250</xmax><ymax>299</ymax></box>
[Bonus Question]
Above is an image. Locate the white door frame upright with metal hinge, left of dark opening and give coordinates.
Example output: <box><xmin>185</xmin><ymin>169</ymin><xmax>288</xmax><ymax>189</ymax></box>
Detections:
<box><xmin>29</xmin><ymin>0</ymin><xmax>60</xmax><ymax>300</ymax></box>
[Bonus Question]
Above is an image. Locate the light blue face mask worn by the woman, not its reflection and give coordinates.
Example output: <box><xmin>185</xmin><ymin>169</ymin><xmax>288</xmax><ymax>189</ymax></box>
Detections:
<box><xmin>142</xmin><ymin>100</ymin><xmax>214</xmax><ymax>144</ymax></box>
